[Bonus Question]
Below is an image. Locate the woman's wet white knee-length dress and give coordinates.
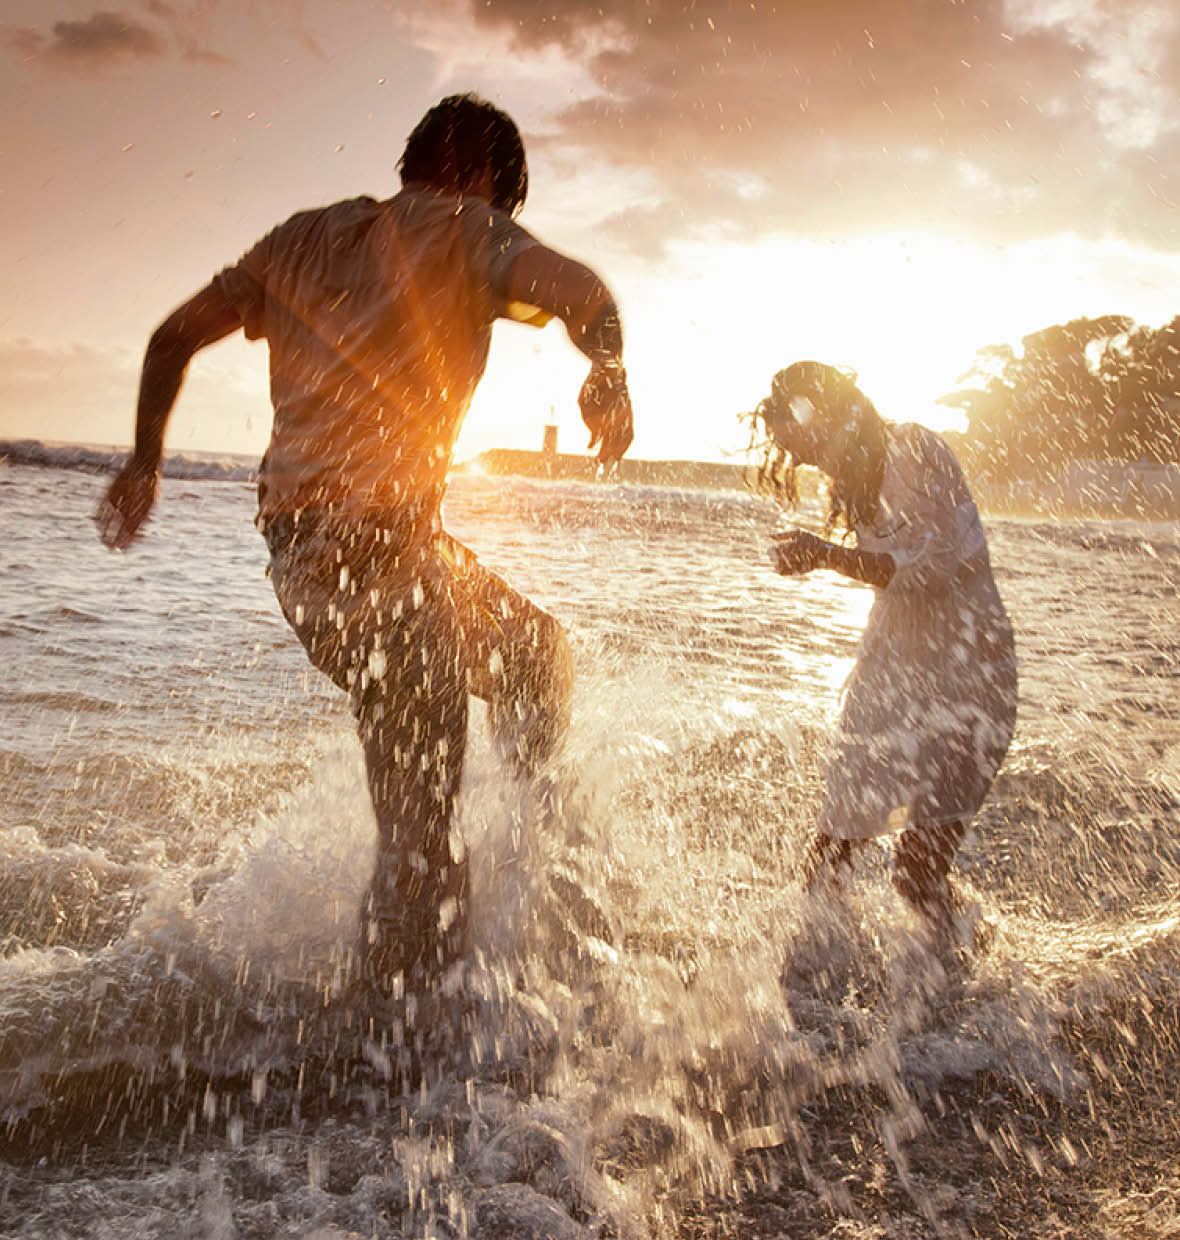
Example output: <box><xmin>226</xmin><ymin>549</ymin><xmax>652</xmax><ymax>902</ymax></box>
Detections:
<box><xmin>819</xmin><ymin>424</ymin><xmax>1016</xmax><ymax>839</ymax></box>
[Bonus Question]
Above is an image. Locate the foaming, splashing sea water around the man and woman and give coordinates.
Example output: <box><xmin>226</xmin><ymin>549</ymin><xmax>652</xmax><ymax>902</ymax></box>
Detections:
<box><xmin>0</xmin><ymin>464</ymin><xmax>1180</xmax><ymax>1240</ymax></box>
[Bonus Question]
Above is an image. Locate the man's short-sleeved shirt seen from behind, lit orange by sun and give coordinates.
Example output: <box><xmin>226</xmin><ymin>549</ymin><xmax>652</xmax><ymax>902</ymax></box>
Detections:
<box><xmin>216</xmin><ymin>187</ymin><xmax>538</xmax><ymax>518</ymax></box>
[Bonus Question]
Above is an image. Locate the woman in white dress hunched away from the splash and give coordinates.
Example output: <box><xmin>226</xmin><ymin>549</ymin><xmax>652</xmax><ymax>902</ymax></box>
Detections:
<box><xmin>755</xmin><ymin>362</ymin><xmax>1016</xmax><ymax>944</ymax></box>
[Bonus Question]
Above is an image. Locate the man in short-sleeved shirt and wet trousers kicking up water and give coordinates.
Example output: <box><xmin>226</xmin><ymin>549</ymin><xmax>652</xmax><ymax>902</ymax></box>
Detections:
<box><xmin>95</xmin><ymin>94</ymin><xmax>632</xmax><ymax>992</ymax></box>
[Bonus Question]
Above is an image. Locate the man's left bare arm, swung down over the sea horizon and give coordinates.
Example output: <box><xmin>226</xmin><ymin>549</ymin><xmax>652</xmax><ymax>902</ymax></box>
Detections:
<box><xmin>94</xmin><ymin>284</ymin><xmax>242</xmax><ymax>551</ymax></box>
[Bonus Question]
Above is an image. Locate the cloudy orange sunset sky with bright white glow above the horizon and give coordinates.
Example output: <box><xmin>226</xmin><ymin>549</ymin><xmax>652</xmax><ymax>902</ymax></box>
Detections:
<box><xmin>0</xmin><ymin>0</ymin><xmax>1180</xmax><ymax>459</ymax></box>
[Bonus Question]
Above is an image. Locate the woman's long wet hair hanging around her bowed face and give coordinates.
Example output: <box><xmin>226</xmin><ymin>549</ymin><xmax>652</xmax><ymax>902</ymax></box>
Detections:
<box><xmin>750</xmin><ymin>362</ymin><xmax>889</xmax><ymax>533</ymax></box>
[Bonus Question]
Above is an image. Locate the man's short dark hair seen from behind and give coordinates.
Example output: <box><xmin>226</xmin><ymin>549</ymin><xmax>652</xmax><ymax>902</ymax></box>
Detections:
<box><xmin>398</xmin><ymin>94</ymin><xmax>528</xmax><ymax>215</ymax></box>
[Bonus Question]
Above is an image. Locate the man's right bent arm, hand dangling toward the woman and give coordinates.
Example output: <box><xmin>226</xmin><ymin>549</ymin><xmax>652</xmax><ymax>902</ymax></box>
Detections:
<box><xmin>501</xmin><ymin>246</ymin><xmax>635</xmax><ymax>465</ymax></box>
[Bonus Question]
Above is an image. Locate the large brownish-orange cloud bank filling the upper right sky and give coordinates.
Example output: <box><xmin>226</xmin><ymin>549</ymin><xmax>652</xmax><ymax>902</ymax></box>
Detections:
<box><xmin>458</xmin><ymin>0</ymin><xmax>1180</xmax><ymax>247</ymax></box>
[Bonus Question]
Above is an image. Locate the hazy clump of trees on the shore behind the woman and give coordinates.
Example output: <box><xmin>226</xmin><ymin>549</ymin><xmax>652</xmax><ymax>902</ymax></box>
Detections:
<box><xmin>940</xmin><ymin>315</ymin><xmax>1180</xmax><ymax>480</ymax></box>
